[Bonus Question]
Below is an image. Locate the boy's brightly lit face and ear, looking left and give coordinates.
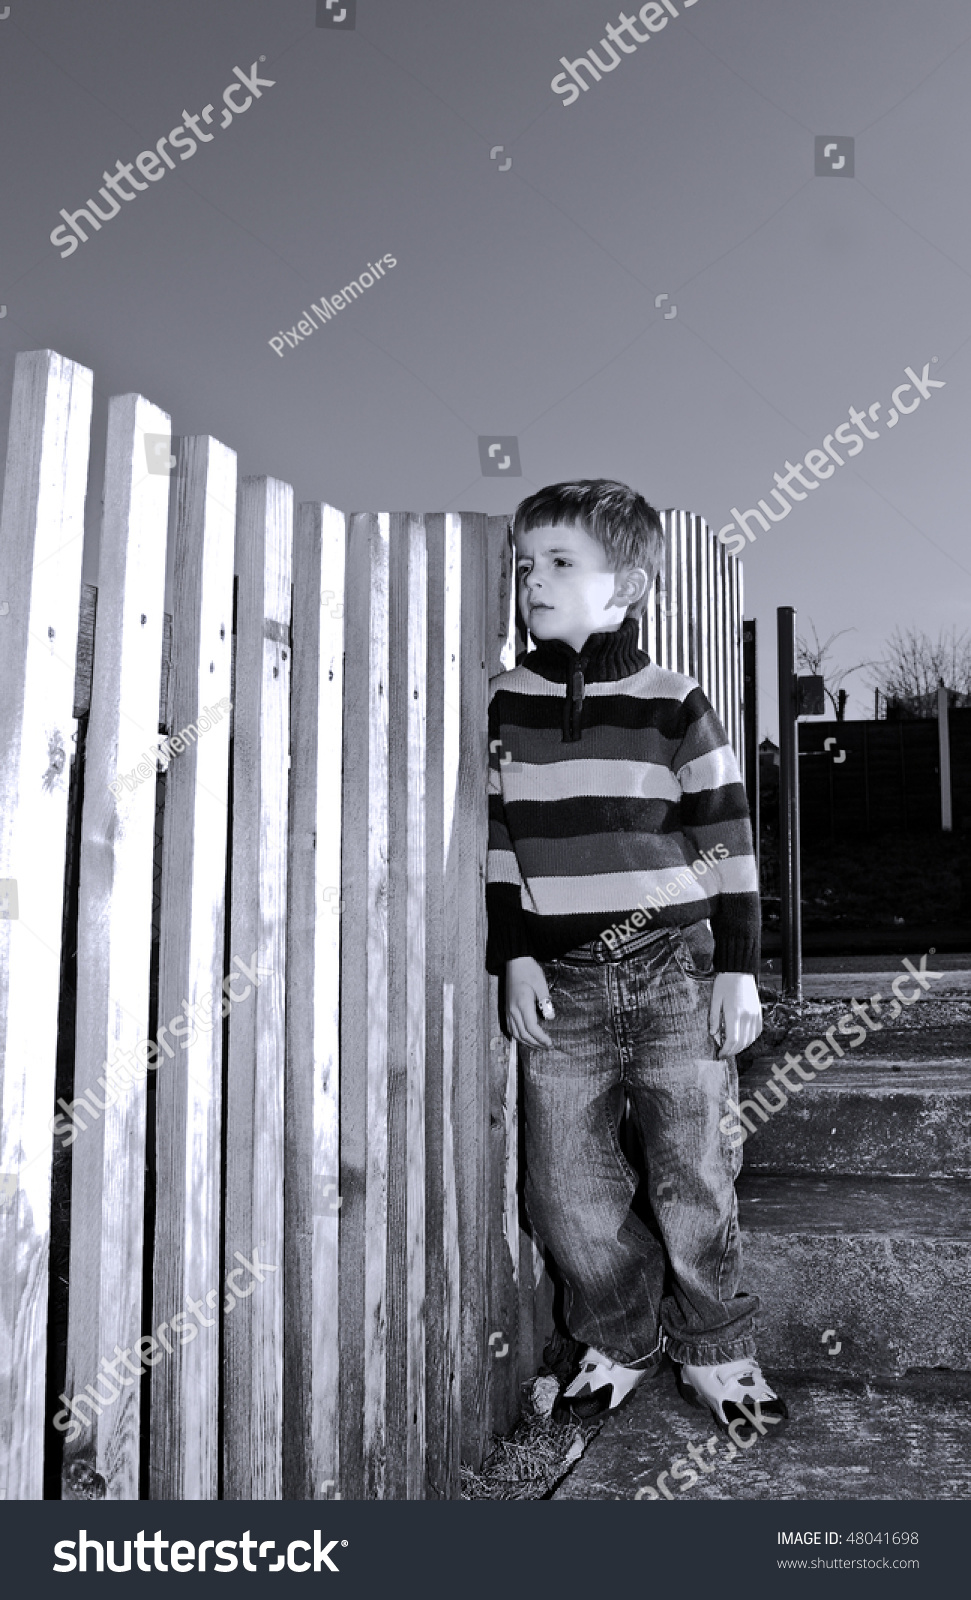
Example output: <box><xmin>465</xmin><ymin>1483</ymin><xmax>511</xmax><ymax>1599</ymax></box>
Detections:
<box><xmin>517</xmin><ymin>523</ymin><xmax>648</xmax><ymax>650</ymax></box>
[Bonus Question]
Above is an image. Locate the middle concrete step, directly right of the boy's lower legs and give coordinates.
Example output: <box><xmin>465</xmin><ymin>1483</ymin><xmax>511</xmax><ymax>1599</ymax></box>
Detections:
<box><xmin>737</xmin><ymin>1177</ymin><xmax>971</xmax><ymax>1376</ymax></box>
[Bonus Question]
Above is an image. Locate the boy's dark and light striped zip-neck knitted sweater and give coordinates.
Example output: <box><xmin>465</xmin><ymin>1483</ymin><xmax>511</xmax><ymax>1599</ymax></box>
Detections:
<box><xmin>486</xmin><ymin>618</ymin><xmax>760</xmax><ymax>976</ymax></box>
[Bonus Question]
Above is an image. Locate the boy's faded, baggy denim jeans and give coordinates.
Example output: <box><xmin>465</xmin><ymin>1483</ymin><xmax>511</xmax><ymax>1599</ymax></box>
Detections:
<box><xmin>520</xmin><ymin>922</ymin><xmax>760</xmax><ymax>1370</ymax></box>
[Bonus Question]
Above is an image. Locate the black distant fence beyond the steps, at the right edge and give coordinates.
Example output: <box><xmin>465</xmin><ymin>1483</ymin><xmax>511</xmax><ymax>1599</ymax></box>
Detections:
<box><xmin>798</xmin><ymin>706</ymin><xmax>971</xmax><ymax>843</ymax></box>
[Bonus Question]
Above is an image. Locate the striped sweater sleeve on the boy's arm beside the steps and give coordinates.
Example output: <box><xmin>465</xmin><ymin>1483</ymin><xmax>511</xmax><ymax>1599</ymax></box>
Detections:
<box><xmin>672</xmin><ymin>686</ymin><xmax>761</xmax><ymax>979</ymax></box>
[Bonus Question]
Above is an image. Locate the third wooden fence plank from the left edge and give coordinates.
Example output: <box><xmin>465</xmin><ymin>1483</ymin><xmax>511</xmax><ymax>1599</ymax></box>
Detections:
<box><xmin>150</xmin><ymin>437</ymin><xmax>236</xmax><ymax>1499</ymax></box>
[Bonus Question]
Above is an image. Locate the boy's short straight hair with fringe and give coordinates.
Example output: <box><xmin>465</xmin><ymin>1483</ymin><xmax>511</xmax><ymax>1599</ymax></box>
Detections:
<box><xmin>512</xmin><ymin>478</ymin><xmax>664</xmax><ymax>619</ymax></box>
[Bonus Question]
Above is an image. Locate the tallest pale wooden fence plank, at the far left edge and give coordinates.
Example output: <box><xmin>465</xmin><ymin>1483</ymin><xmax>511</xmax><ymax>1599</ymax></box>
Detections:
<box><xmin>0</xmin><ymin>350</ymin><xmax>93</xmax><ymax>1499</ymax></box>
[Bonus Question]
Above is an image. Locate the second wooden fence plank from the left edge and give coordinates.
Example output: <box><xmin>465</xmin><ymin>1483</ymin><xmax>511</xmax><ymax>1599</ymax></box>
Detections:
<box><xmin>61</xmin><ymin>395</ymin><xmax>171</xmax><ymax>1499</ymax></box>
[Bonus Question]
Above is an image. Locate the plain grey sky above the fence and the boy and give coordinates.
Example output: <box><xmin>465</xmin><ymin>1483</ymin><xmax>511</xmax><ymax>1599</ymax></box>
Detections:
<box><xmin>0</xmin><ymin>0</ymin><xmax>971</xmax><ymax>738</ymax></box>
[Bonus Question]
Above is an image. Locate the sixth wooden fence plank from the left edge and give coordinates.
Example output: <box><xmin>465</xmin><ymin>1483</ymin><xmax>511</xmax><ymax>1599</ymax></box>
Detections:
<box><xmin>339</xmin><ymin>512</ymin><xmax>390</xmax><ymax>1499</ymax></box>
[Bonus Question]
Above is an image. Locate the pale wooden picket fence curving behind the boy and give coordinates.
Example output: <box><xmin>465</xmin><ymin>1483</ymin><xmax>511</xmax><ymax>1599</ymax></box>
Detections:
<box><xmin>0</xmin><ymin>350</ymin><xmax>742</xmax><ymax>1499</ymax></box>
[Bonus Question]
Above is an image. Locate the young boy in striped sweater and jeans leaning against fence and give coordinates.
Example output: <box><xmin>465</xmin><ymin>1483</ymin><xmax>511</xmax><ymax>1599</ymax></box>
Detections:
<box><xmin>486</xmin><ymin>478</ymin><xmax>787</xmax><ymax>1434</ymax></box>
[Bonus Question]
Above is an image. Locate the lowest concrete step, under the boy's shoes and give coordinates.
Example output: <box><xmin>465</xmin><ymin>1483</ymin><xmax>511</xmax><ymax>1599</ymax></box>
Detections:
<box><xmin>552</xmin><ymin>1370</ymin><xmax>971</xmax><ymax>1497</ymax></box>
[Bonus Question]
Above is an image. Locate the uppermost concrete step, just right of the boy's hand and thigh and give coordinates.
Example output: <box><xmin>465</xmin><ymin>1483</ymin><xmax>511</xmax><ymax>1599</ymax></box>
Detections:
<box><xmin>739</xmin><ymin>1040</ymin><xmax>971</xmax><ymax>1178</ymax></box>
